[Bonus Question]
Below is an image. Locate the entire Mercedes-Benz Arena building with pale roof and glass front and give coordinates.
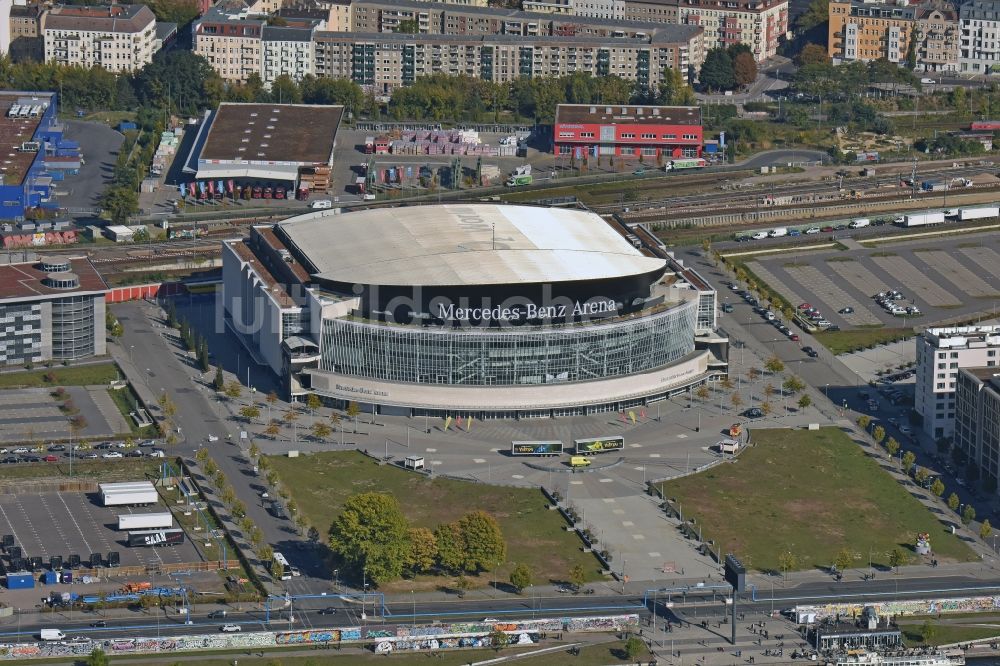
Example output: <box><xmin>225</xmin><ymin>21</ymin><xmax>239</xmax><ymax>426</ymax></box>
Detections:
<box><xmin>223</xmin><ymin>204</ymin><xmax>727</xmax><ymax>418</ymax></box>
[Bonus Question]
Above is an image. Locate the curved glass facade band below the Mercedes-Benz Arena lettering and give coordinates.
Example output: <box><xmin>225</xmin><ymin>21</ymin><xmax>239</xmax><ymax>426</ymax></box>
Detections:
<box><xmin>320</xmin><ymin>300</ymin><xmax>698</xmax><ymax>386</ymax></box>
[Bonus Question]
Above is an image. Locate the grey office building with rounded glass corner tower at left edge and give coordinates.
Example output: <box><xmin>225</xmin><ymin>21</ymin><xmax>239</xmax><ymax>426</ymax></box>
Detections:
<box><xmin>0</xmin><ymin>256</ymin><xmax>108</xmax><ymax>365</ymax></box>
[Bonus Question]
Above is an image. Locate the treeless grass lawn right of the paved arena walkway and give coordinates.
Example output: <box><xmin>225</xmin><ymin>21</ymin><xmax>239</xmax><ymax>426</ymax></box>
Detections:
<box><xmin>664</xmin><ymin>428</ymin><xmax>974</xmax><ymax>571</ymax></box>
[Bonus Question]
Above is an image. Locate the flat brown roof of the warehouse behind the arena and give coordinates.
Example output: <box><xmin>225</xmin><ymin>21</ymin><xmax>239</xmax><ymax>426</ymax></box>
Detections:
<box><xmin>199</xmin><ymin>103</ymin><xmax>344</xmax><ymax>164</ymax></box>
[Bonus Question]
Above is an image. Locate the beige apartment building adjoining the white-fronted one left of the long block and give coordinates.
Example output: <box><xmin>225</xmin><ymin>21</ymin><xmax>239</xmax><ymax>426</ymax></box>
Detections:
<box><xmin>191</xmin><ymin>7</ymin><xmax>266</xmax><ymax>83</ymax></box>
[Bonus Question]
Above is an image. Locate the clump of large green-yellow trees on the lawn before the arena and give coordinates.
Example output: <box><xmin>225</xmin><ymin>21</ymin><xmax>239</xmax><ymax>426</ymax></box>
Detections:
<box><xmin>329</xmin><ymin>492</ymin><xmax>507</xmax><ymax>584</ymax></box>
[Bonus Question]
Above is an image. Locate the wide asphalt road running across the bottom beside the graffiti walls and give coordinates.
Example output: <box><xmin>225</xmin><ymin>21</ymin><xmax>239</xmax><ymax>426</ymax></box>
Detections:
<box><xmin>7</xmin><ymin>573</ymin><xmax>1000</xmax><ymax>640</ymax></box>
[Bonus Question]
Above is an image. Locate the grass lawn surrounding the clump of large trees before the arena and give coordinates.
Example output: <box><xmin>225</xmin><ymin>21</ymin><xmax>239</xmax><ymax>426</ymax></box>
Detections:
<box><xmin>269</xmin><ymin>451</ymin><xmax>601</xmax><ymax>592</ymax></box>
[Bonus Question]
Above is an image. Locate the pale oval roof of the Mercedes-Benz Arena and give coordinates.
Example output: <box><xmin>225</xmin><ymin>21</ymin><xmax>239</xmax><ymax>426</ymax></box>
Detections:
<box><xmin>277</xmin><ymin>204</ymin><xmax>666</xmax><ymax>286</ymax></box>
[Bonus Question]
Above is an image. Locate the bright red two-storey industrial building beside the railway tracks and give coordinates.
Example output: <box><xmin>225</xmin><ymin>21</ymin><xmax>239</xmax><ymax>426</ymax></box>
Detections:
<box><xmin>552</xmin><ymin>104</ymin><xmax>704</xmax><ymax>160</ymax></box>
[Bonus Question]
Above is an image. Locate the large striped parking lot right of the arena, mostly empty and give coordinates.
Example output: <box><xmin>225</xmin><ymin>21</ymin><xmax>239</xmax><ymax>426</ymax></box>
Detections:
<box><xmin>744</xmin><ymin>233</ymin><xmax>1000</xmax><ymax>330</ymax></box>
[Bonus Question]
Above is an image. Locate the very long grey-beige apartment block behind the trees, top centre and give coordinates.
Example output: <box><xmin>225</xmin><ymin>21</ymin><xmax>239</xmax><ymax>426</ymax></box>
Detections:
<box><xmin>315</xmin><ymin>26</ymin><xmax>704</xmax><ymax>92</ymax></box>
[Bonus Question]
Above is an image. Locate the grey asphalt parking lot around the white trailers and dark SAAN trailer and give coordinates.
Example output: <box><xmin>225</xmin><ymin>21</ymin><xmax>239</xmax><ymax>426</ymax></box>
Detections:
<box><xmin>0</xmin><ymin>492</ymin><xmax>201</xmax><ymax>567</ymax></box>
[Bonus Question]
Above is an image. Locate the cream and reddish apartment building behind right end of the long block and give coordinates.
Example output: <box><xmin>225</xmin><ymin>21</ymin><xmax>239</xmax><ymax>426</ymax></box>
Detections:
<box><xmin>676</xmin><ymin>0</ymin><xmax>788</xmax><ymax>62</ymax></box>
